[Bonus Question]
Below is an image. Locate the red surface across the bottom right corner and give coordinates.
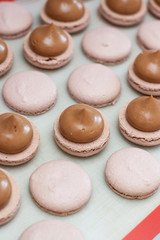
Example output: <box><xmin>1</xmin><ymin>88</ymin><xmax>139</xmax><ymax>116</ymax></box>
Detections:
<box><xmin>122</xmin><ymin>205</ymin><xmax>160</xmax><ymax>240</ymax></box>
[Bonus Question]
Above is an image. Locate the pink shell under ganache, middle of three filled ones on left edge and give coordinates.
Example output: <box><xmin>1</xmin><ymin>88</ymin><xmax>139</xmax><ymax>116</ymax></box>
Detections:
<box><xmin>0</xmin><ymin>118</ymin><xmax>40</xmax><ymax>166</ymax></box>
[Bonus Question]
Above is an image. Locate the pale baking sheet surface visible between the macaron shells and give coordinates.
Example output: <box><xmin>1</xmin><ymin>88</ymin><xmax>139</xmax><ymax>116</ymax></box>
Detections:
<box><xmin>0</xmin><ymin>0</ymin><xmax>160</xmax><ymax>240</ymax></box>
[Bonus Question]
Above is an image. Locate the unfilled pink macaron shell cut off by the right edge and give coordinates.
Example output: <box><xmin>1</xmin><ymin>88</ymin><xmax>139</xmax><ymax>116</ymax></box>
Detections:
<box><xmin>137</xmin><ymin>20</ymin><xmax>160</xmax><ymax>50</ymax></box>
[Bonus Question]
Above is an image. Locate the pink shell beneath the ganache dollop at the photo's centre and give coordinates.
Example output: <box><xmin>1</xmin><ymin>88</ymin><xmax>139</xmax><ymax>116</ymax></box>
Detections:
<box><xmin>54</xmin><ymin>114</ymin><xmax>110</xmax><ymax>157</ymax></box>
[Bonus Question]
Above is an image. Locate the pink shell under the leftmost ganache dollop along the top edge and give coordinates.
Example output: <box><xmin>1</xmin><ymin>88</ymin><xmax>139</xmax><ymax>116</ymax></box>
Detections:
<box><xmin>40</xmin><ymin>4</ymin><xmax>90</xmax><ymax>33</ymax></box>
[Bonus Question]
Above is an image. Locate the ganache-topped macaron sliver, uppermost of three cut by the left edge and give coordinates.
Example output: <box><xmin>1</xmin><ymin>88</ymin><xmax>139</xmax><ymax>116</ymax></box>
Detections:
<box><xmin>0</xmin><ymin>38</ymin><xmax>14</xmax><ymax>76</ymax></box>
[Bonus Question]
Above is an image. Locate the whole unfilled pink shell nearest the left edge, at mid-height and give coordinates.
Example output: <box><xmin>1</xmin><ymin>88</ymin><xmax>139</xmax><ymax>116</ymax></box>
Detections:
<box><xmin>3</xmin><ymin>71</ymin><xmax>57</xmax><ymax>115</ymax></box>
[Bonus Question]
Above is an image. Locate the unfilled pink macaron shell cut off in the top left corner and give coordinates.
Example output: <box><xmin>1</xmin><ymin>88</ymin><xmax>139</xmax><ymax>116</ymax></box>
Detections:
<box><xmin>0</xmin><ymin>2</ymin><xmax>32</xmax><ymax>39</ymax></box>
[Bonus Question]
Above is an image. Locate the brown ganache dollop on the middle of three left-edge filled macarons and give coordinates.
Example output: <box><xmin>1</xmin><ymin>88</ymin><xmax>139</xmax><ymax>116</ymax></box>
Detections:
<box><xmin>0</xmin><ymin>113</ymin><xmax>33</xmax><ymax>154</ymax></box>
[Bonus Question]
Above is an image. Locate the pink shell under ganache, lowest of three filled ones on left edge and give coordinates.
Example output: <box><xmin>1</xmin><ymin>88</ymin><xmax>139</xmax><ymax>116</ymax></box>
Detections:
<box><xmin>0</xmin><ymin>169</ymin><xmax>21</xmax><ymax>226</ymax></box>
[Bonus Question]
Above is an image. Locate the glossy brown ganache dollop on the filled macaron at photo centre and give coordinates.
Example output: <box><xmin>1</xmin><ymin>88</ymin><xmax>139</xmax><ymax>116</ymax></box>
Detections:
<box><xmin>59</xmin><ymin>104</ymin><xmax>104</xmax><ymax>143</ymax></box>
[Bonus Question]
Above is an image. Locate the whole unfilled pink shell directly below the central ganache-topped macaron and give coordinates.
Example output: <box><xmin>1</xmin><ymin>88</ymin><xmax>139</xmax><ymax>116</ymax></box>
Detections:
<box><xmin>29</xmin><ymin>160</ymin><xmax>92</xmax><ymax>216</ymax></box>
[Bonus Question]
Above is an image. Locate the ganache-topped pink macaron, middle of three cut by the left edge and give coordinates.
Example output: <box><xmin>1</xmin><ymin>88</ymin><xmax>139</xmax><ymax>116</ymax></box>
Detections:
<box><xmin>0</xmin><ymin>113</ymin><xmax>40</xmax><ymax>166</ymax></box>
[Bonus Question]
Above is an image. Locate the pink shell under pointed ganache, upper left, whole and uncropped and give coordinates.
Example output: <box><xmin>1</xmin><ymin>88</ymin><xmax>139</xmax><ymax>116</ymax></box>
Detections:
<box><xmin>23</xmin><ymin>32</ymin><xmax>73</xmax><ymax>69</ymax></box>
